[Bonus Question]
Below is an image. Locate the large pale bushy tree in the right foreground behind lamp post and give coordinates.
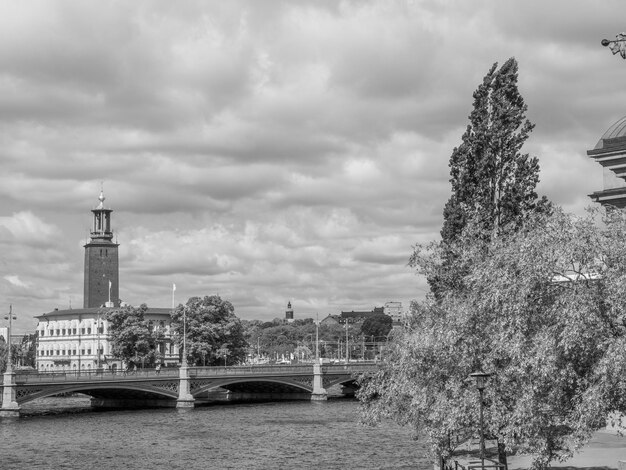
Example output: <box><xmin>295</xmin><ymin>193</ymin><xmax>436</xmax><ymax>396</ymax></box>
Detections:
<box><xmin>360</xmin><ymin>210</ymin><xmax>626</xmax><ymax>469</ymax></box>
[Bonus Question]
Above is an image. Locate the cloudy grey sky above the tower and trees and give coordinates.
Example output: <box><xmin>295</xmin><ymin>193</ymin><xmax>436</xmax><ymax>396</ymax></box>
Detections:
<box><xmin>0</xmin><ymin>0</ymin><xmax>626</xmax><ymax>332</ymax></box>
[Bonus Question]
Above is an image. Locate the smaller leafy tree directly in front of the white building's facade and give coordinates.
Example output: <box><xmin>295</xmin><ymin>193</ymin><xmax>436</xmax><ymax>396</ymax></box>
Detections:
<box><xmin>106</xmin><ymin>304</ymin><xmax>163</xmax><ymax>367</ymax></box>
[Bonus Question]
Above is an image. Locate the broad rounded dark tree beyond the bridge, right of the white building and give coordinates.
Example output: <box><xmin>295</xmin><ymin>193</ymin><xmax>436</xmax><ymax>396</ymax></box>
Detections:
<box><xmin>172</xmin><ymin>295</ymin><xmax>248</xmax><ymax>365</ymax></box>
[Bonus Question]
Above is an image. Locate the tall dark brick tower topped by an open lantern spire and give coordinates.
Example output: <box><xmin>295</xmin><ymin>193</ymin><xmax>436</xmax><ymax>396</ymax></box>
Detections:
<box><xmin>83</xmin><ymin>191</ymin><xmax>119</xmax><ymax>308</ymax></box>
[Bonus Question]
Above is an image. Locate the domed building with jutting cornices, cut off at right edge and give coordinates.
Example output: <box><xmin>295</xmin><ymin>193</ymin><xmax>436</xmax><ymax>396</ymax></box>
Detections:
<box><xmin>587</xmin><ymin>116</ymin><xmax>626</xmax><ymax>209</ymax></box>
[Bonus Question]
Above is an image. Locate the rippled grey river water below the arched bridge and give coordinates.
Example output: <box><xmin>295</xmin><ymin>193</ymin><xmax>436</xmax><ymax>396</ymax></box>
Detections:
<box><xmin>0</xmin><ymin>396</ymin><xmax>432</xmax><ymax>470</ymax></box>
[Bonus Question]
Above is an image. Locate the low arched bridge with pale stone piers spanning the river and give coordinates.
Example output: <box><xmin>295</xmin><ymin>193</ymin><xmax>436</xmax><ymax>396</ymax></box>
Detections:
<box><xmin>0</xmin><ymin>362</ymin><xmax>377</xmax><ymax>417</ymax></box>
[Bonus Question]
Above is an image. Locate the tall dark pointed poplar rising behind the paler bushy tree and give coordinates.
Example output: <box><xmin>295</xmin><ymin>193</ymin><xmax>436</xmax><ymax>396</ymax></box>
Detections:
<box><xmin>432</xmin><ymin>58</ymin><xmax>549</xmax><ymax>297</ymax></box>
